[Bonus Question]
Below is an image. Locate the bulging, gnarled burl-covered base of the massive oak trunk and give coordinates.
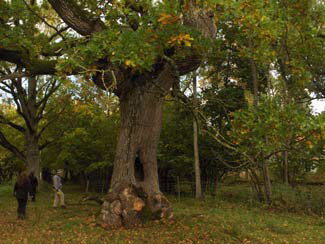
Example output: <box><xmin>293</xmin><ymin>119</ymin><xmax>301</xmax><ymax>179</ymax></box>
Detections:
<box><xmin>97</xmin><ymin>182</ymin><xmax>173</xmax><ymax>229</ymax></box>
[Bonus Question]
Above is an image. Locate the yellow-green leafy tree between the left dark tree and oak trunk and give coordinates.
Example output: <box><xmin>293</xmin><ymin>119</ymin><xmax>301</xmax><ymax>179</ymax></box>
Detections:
<box><xmin>42</xmin><ymin>81</ymin><xmax>119</xmax><ymax>189</ymax></box>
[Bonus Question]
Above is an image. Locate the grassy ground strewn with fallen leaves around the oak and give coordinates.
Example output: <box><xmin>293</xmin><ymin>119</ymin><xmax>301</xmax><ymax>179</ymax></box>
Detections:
<box><xmin>0</xmin><ymin>183</ymin><xmax>325</xmax><ymax>244</ymax></box>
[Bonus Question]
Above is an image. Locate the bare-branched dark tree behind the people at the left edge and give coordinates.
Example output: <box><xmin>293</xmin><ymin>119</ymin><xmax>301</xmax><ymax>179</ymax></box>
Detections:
<box><xmin>0</xmin><ymin>72</ymin><xmax>59</xmax><ymax>177</ymax></box>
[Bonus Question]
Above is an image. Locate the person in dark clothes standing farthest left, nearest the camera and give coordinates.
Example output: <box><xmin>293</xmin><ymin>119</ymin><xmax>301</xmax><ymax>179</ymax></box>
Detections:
<box><xmin>14</xmin><ymin>171</ymin><xmax>31</xmax><ymax>219</ymax></box>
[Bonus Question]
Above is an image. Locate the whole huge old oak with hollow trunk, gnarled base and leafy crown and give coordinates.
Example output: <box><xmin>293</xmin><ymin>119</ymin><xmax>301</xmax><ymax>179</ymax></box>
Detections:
<box><xmin>0</xmin><ymin>0</ymin><xmax>215</xmax><ymax>227</ymax></box>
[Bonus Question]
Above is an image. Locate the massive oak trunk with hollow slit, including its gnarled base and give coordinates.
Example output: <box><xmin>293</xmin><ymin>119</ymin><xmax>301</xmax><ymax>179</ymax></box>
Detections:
<box><xmin>97</xmin><ymin>71</ymin><xmax>172</xmax><ymax>228</ymax></box>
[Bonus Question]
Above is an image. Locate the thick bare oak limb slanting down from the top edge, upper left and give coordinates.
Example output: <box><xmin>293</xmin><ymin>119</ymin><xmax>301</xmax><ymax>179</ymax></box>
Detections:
<box><xmin>48</xmin><ymin>0</ymin><xmax>105</xmax><ymax>36</ymax></box>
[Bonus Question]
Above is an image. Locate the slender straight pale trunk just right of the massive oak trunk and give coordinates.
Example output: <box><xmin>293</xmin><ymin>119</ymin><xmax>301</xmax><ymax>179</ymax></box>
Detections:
<box><xmin>193</xmin><ymin>75</ymin><xmax>202</xmax><ymax>199</ymax></box>
